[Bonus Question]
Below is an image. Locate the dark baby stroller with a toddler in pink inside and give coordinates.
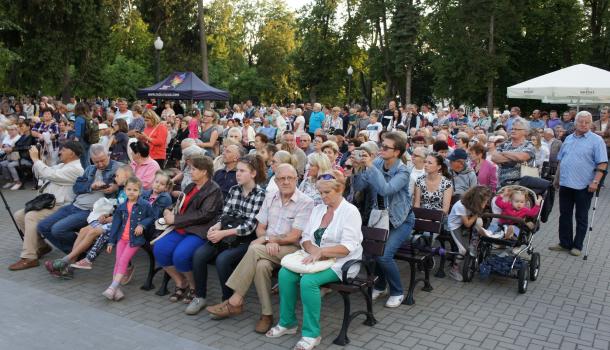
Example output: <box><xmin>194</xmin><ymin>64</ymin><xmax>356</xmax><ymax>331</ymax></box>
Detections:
<box><xmin>462</xmin><ymin>177</ymin><xmax>551</xmax><ymax>294</ymax></box>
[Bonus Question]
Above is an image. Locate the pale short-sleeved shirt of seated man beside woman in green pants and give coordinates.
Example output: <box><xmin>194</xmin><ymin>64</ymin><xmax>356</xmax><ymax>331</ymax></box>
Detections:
<box><xmin>256</xmin><ymin>189</ymin><xmax>313</xmax><ymax>236</ymax></box>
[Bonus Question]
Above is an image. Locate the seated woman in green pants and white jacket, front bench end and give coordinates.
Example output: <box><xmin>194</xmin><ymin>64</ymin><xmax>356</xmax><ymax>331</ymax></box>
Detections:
<box><xmin>267</xmin><ymin>170</ymin><xmax>362</xmax><ymax>350</ymax></box>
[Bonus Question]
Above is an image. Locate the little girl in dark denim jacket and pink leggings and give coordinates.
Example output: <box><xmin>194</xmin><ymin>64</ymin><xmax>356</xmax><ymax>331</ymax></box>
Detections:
<box><xmin>102</xmin><ymin>177</ymin><xmax>156</xmax><ymax>301</ymax></box>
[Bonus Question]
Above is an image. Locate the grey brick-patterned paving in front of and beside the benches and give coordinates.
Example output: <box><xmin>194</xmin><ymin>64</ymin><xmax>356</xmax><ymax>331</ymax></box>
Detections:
<box><xmin>0</xmin><ymin>190</ymin><xmax>610</xmax><ymax>350</ymax></box>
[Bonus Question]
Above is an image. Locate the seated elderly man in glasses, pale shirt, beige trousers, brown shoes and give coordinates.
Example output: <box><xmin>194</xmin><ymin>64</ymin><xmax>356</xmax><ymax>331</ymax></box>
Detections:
<box><xmin>206</xmin><ymin>164</ymin><xmax>313</xmax><ymax>334</ymax></box>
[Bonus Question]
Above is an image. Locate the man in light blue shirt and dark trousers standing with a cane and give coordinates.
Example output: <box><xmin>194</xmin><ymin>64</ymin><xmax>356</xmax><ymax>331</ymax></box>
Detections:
<box><xmin>549</xmin><ymin>111</ymin><xmax>608</xmax><ymax>256</ymax></box>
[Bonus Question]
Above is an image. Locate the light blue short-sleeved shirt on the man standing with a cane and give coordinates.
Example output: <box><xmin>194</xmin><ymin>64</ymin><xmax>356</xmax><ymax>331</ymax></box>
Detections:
<box><xmin>557</xmin><ymin>131</ymin><xmax>608</xmax><ymax>190</ymax></box>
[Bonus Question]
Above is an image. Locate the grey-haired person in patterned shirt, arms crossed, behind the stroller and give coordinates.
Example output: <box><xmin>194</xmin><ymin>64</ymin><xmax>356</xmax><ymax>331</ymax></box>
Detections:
<box><xmin>491</xmin><ymin>118</ymin><xmax>536</xmax><ymax>186</ymax></box>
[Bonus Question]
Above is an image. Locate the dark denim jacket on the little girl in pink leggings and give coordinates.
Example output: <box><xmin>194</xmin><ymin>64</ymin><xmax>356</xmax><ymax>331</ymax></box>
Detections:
<box><xmin>108</xmin><ymin>197</ymin><xmax>156</xmax><ymax>247</ymax></box>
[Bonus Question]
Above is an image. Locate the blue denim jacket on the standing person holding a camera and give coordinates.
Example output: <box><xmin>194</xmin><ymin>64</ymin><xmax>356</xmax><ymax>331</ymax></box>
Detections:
<box><xmin>354</xmin><ymin>157</ymin><xmax>411</xmax><ymax>227</ymax></box>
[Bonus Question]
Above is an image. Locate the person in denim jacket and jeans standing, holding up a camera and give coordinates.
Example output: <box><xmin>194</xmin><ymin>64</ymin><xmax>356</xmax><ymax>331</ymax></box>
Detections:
<box><xmin>353</xmin><ymin>132</ymin><xmax>415</xmax><ymax>307</ymax></box>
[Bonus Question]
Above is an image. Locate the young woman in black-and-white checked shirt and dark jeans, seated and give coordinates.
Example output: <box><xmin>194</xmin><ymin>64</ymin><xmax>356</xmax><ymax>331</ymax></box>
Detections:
<box><xmin>185</xmin><ymin>154</ymin><xmax>267</xmax><ymax>315</ymax></box>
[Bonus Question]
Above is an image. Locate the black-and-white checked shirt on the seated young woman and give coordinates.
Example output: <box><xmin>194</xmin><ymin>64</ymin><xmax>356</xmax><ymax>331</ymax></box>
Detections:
<box><xmin>219</xmin><ymin>185</ymin><xmax>265</xmax><ymax>236</ymax></box>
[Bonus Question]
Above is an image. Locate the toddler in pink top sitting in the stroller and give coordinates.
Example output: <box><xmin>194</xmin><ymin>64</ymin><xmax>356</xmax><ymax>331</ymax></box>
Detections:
<box><xmin>481</xmin><ymin>188</ymin><xmax>542</xmax><ymax>239</ymax></box>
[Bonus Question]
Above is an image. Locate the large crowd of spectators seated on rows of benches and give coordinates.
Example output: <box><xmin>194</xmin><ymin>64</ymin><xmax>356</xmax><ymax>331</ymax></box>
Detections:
<box><xmin>0</xmin><ymin>93</ymin><xmax>610</xmax><ymax>349</ymax></box>
